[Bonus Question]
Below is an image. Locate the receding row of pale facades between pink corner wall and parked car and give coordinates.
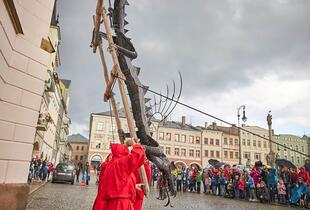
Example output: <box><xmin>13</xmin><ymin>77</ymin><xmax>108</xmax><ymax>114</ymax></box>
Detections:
<box><xmin>33</xmin><ymin>3</ymin><xmax>71</xmax><ymax>165</ymax></box>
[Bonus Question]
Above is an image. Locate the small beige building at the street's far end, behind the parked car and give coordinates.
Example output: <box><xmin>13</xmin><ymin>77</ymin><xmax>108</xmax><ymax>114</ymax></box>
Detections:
<box><xmin>68</xmin><ymin>133</ymin><xmax>89</xmax><ymax>164</ymax></box>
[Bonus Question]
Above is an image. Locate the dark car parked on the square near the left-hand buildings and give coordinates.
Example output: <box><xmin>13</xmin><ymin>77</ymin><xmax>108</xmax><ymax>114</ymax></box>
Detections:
<box><xmin>52</xmin><ymin>163</ymin><xmax>75</xmax><ymax>184</ymax></box>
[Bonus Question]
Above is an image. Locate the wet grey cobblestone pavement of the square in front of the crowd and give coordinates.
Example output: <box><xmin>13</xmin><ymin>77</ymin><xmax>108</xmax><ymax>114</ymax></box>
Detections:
<box><xmin>27</xmin><ymin>183</ymin><xmax>293</xmax><ymax>210</ymax></box>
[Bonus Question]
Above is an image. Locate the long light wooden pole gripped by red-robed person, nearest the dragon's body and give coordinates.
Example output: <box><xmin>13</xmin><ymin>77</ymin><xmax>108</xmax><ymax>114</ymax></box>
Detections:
<box><xmin>99</xmin><ymin>0</ymin><xmax>150</xmax><ymax>196</ymax></box>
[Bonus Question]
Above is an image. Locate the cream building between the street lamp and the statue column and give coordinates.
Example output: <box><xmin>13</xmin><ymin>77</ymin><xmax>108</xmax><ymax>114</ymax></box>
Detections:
<box><xmin>240</xmin><ymin>126</ymin><xmax>270</xmax><ymax>164</ymax></box>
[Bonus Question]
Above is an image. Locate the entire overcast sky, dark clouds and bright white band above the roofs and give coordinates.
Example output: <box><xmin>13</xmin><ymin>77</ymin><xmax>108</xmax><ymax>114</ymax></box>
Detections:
<box><xmin>58</xmin><ymin>0</ymin><xmax>310</xmax><ymax>136</ymax></box>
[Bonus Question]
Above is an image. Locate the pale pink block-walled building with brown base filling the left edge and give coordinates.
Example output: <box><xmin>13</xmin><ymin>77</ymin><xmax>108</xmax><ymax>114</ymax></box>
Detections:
<box><xmin>0</xmin><ymin>0</ymin><xmax>54</xmax><ymax>209</ymax></box>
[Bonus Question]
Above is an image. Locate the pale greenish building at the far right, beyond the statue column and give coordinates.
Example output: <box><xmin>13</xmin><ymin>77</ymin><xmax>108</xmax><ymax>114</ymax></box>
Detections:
<box><xmin>272</xmin><ymin>134</ymin><xmax>309</xmax><ymax>167</ymax></box>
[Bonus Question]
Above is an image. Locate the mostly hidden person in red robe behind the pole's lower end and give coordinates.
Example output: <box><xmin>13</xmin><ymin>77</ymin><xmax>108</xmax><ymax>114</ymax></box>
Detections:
<box><xmin>134</xmin><ymin>158</ymin><xmax>151</xmax><ymax>210</ymax></box>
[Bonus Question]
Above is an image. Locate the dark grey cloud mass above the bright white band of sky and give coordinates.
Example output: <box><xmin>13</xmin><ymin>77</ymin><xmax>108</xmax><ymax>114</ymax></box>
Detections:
<box><xmin>58</xmin><ymin>0</ymin><xmax>310</xmax><ymax>134</ymax></box>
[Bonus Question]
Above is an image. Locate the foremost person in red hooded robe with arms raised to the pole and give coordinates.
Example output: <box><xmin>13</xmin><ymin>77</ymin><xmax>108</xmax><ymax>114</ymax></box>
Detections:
<box><xmin>93</xmin><ymin>140</ymin><xmax>145</xmax><ymax>210</ymax></box>
